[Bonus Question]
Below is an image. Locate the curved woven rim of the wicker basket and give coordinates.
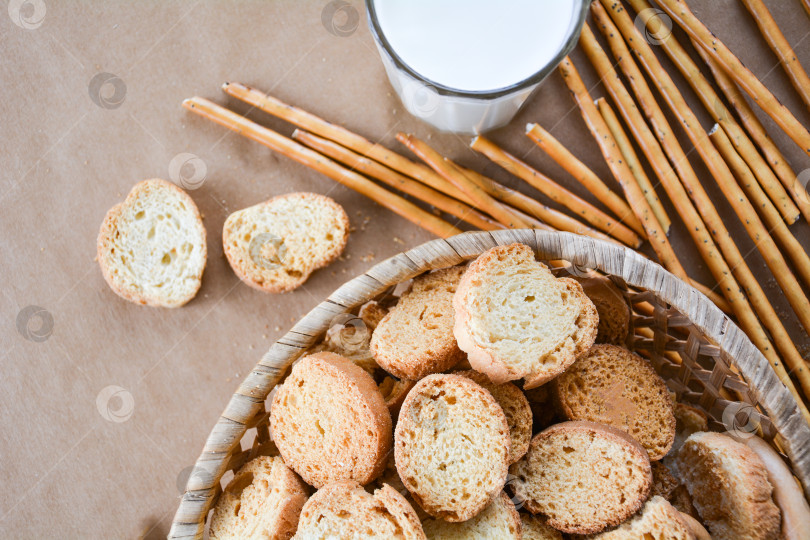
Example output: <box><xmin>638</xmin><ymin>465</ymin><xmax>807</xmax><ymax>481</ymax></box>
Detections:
<box><xmin>168</xmin><ymin>229</ymin><xmax>810</xmax><ymax>539</ymax></box>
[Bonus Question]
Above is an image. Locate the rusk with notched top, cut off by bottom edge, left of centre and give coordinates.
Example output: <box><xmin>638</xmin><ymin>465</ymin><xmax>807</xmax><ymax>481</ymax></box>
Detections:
<box><xmin>295</xmin><ymin>480</ymin><xmax>425</xmax><ymax>540</ymax></box>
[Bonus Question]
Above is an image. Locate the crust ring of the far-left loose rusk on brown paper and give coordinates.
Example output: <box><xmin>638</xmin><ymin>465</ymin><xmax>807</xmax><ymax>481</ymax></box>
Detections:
<box><xmin>96</xmin><ymin>178</ymin><xmax>208</xmax><ymax>308</ymax></box>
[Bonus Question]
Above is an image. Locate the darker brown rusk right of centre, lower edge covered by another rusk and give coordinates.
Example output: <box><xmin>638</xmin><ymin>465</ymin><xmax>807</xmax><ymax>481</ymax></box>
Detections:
<box><xmin>552</xmin><ymin>345</ymin><xmax>675</xmax><ymax>460</ymax></box>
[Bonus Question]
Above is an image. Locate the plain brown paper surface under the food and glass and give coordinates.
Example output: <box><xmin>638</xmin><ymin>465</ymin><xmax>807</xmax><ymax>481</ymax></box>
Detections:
<box><xmin>0</xmin><ymin>0</ymin><xmax>810</xmax><ymax>538</ymax></box>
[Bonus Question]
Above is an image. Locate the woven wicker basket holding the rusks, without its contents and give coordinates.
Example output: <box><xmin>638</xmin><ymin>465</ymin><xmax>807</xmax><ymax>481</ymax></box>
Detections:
<box><xmin>169</xmin><ymin>230</ymin><xmax>810</xmax><ymax>538</ymax></box>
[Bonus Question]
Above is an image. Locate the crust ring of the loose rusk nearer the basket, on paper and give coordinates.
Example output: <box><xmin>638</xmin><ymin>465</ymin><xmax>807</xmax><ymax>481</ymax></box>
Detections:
<box><xmin>222</xmin><ymin>192</ymin><xmax>349</xmax><ymax>293</ymax></box>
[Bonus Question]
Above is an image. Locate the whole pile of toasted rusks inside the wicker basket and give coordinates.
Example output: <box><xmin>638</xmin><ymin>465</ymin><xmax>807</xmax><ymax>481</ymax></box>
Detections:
<box><xmin>210</xmin><ymin>244</ymin><xmax>788</xmax><ymax>540</ymax></box>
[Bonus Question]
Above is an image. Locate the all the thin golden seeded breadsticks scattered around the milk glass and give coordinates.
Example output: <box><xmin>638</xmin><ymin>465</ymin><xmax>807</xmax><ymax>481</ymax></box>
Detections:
<box><xmin>183</xmin><ymin>0</ymin><xmax>810</xmax><ymax>419</ymax></box>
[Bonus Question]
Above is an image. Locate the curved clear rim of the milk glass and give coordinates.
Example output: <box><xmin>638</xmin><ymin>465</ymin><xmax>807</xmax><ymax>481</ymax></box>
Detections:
<box><xmin>365</xmin><ymin>0</ymin><xmax>590</xmax><ymax>99</ymax></box>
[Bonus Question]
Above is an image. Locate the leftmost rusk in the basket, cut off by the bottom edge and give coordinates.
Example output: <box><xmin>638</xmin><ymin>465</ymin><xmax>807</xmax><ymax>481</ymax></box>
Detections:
<box><xmin>210</xmin><ymin>456</ymin><xmax>309</xmax><ymax>540</ymax></box>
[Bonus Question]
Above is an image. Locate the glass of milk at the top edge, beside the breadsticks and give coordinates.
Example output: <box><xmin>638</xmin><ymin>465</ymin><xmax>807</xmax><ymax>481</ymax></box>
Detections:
<box><xmin>366</xmin><ymin>0</ymin><xmax>589</xmax><ymax>134</ymax></box>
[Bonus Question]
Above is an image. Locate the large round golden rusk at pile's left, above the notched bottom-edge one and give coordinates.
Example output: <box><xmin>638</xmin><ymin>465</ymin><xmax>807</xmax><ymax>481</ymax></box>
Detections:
<box><xmin>270</xmin><ymin>352</ymin><xmax>392</xmax><ymax>488</ymax></box>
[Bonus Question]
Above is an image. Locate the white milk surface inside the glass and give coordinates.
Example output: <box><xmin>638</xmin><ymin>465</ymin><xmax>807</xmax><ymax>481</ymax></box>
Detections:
<box><xmin>374</xmin><ymin>0</ymin><xmax>581</xmax><ymax>91</ymax></box>
